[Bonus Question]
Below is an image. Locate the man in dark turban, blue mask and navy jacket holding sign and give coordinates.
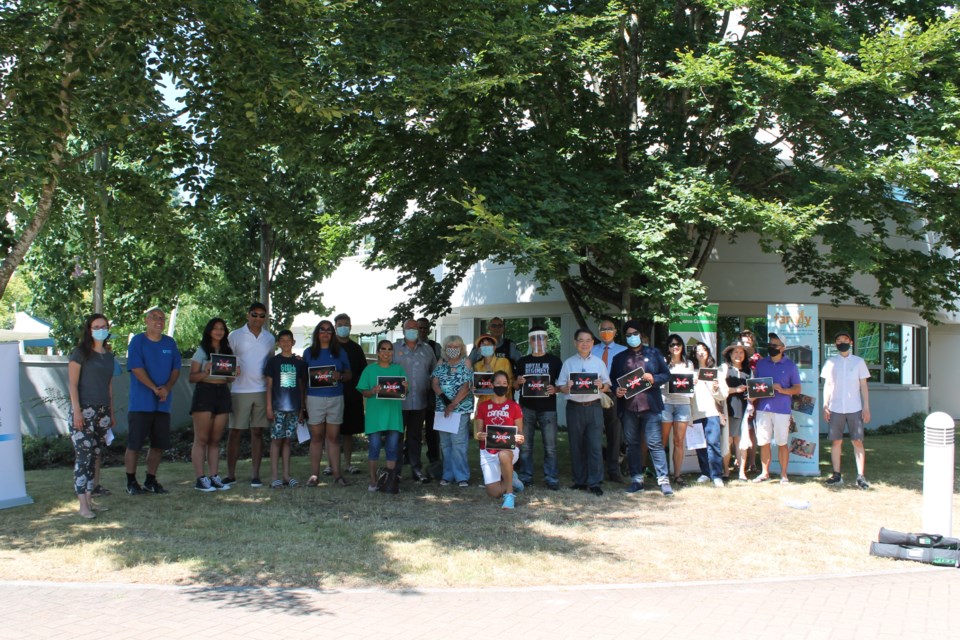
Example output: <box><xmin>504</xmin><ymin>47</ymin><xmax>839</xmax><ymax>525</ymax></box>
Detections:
<box><xmin>610</xmin><ymin>320</ymin><xmax>673</xmax><ymax>497</ymax></box>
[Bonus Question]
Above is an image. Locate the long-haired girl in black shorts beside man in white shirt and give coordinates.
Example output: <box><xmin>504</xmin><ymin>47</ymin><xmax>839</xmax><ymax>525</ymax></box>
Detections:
<box><xmin>189</xmin><ymin>318</ymin><xmax>233</xmax><ymax>493</ymax></box>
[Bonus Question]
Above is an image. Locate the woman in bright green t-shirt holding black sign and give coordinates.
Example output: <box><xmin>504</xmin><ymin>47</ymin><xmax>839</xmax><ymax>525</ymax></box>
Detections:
<box><xmin>357</xmin><ymin>340</ymin><xmax>407</xmax><ymax>493</ymax></box>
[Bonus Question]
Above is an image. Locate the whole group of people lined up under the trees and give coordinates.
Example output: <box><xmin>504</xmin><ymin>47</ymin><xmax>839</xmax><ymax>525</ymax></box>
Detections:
<box><xmin>63</xmin><ymin>303</ymin><xmax>870</xmax><ymax>518</ymax></box>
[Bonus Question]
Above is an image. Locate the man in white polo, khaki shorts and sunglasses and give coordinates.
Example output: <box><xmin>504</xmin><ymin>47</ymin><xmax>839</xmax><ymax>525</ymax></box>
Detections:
<box><xmin>223</xmin><ymin>302</ymin><xmax>276</xmax><ymax>488</ymax></box>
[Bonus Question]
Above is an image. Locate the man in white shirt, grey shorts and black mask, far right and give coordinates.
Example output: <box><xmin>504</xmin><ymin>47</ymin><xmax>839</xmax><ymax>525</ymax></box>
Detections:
<box><xmin>820</xmin><ymin>331</ymin><xmax>870</xmax><ymax>489</ymax></box>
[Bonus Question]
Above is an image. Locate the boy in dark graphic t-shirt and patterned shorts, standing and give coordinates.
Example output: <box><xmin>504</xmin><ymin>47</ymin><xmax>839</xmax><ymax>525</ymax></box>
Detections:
<box><xmin>263</xmin><ymin>329</ymin><xmax>307</xmax><ymax>489</ymax></box>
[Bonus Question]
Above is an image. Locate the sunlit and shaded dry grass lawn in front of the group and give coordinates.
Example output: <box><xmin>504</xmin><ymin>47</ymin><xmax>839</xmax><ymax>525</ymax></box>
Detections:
<box><xmin>0</xmin><ymin>433</ymin><xmax>958</xmax><ymax>588</ymax></box>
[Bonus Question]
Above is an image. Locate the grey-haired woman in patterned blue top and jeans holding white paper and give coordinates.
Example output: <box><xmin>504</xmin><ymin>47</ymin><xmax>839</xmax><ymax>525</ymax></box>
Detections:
<box><xmin>432</xmin><ymin>336</ymin><xmax>473</xmax><ymax>487</ymax></box>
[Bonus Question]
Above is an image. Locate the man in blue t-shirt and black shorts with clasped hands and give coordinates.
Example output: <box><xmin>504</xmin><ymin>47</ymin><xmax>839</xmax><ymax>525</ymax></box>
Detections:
<box><xmin>124</xmin><ymin>307</ymin><xmax>180</xmax><ymax>496</ymax></box>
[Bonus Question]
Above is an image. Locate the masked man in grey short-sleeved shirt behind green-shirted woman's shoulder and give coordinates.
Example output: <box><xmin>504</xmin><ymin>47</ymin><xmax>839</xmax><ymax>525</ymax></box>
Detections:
<box><xmin>393</xmin><ymin>318</ymin><xmax>437</xmax><ymax>484</ymax></box>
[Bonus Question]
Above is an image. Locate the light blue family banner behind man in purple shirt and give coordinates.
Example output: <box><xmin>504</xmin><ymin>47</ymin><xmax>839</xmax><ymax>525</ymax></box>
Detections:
<box><xmin>767</xmin><ymin>304</ymin><xmax>820</xmax><ymax>476</ymax></box>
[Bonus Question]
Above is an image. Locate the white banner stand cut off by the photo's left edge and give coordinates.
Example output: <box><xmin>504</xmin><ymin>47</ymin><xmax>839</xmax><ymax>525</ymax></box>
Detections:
<box><xmin>0</xmin><ymin>342</ymin><xmax>33</xmax><ymax>509</ymax></box>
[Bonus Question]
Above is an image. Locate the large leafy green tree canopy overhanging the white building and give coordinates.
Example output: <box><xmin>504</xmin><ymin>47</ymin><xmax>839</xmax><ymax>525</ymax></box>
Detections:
<box><xmin>318</xmin><ymin>0</ymin><xmax>960</xmax><ymax>323</ymax></box>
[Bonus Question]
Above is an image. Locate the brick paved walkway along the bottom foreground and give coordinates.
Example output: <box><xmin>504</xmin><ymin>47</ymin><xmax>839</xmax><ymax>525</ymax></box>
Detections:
<box><xmin>0</xmin><ymin>567</ymin><xmax>960</xmax><ymax>640</ymax></box>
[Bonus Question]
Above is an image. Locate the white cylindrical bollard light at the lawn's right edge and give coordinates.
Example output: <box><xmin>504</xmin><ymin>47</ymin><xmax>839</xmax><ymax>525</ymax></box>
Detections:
<box><xmin>923</xmin><ymin>411</ymin><xmax>956</xmax><ymax>536</ymax></box>
